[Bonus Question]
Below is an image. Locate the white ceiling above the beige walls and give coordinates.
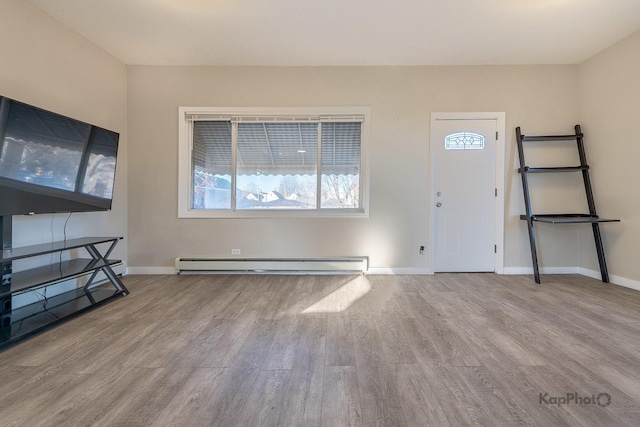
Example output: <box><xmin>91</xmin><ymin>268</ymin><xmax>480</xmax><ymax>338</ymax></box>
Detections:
<box><xmin>29</xmin><ymin>0</ymin><xmax>640</xmax><ymax>66</ymax></box>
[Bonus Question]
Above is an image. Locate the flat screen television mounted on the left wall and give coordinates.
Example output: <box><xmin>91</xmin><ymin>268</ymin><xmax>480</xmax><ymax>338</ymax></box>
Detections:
<box><xmin>0</xmin><ymin>96</ymin><xmax>120</xmax><ymax>216</ymax></box>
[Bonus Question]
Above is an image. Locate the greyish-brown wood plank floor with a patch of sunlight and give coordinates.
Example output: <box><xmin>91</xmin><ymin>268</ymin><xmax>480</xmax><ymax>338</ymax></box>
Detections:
<box><xmin>0</xmin><ymin>274</ymin><xmax>640</xmax><ymax>427</ymax></box>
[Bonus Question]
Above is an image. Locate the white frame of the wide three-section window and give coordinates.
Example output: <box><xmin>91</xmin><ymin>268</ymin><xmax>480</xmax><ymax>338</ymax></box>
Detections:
<box><xmin>178</xmin><ymin>107</ymin><xmax>371</xmax><ymax>218</ymax></box>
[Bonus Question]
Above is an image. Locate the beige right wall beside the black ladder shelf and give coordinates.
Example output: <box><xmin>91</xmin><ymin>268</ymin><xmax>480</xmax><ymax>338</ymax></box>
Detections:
<box><xmin>578</xmin><ymin>32</ymin><xmax>640</xmax><ymax>281</ymax></box>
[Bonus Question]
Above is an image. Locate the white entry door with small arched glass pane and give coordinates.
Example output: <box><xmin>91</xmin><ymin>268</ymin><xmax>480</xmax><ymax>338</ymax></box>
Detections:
<box><xmin>431</xmin><ymin>119</ymin><xmax>498</xmax><ymax>272</ymax></box>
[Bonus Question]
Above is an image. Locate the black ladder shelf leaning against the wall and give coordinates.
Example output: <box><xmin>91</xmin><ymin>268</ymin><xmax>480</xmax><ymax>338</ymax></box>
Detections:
<box><xmin>516</xmin><ymin>125</ymin><xmax>620</xmax><ymax>284</ymax></box>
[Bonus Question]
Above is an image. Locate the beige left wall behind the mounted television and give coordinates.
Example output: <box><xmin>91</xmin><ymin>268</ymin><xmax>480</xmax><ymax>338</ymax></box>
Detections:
<box><xmin>0</xmin><ymin>0</ymin><xmax>127</xmax><ymax>259</ymax></box>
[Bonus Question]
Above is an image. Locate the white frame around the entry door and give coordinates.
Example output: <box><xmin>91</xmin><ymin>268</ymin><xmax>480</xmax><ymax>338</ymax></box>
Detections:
<box><xmin>429</xmin><ymin>112</ymin><xmax>506</xmax><ymax>274</ymax></box>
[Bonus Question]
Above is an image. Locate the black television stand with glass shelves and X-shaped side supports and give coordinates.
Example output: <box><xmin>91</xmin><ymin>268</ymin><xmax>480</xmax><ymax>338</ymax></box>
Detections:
<box><xmin>0</xmin><ymin>216</ymin><xmax>129</xmax><ymax>348</ymax></box>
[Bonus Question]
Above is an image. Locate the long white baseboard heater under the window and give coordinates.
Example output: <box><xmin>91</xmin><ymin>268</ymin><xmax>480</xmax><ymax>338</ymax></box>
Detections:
<box><xmin>176</xmin><ymin>257</ymin><xmax>369</xmax><ymax>274</ymax></box>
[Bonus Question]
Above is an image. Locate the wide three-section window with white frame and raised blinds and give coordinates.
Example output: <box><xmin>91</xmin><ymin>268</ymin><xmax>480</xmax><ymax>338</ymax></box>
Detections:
<box><xmin>178</xmin><ymin>107</ymin><xmax>369</xmax><ymax>217</ymax></box>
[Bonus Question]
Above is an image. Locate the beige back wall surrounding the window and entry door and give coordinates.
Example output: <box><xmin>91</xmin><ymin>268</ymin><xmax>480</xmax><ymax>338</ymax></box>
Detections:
<box><xmin>128</xmin><ymin>66</ymin><xmax>578</xmax><ymax>271</ymax></box>
